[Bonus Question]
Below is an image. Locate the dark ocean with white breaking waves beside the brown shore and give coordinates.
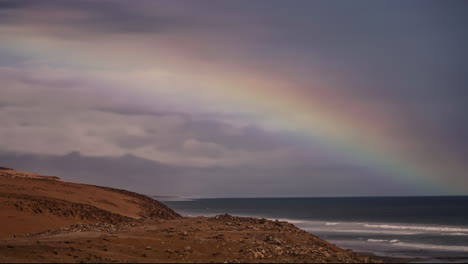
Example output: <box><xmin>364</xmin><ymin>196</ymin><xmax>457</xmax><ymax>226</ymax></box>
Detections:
<box><xmin>162</xmin><ymin>196</ymin><xmax>468</xmax><ymax>262</ymax></box>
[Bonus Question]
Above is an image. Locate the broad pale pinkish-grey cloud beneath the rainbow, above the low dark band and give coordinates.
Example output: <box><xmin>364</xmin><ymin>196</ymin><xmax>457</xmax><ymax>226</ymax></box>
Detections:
<box><xmin>0</xmin><ymin>68</ymin><xmax>304</xmax><ymax>167</ymax></box>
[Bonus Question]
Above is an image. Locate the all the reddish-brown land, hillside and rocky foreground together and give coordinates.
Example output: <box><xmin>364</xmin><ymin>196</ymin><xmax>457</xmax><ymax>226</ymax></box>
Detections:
<box><xmin>0</xmin><ymin>168</ymin><xmax>380</xmax><ymax>263</ymax></box>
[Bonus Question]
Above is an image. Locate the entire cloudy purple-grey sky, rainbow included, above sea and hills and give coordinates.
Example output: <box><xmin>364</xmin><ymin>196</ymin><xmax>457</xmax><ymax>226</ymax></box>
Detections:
<box><xmin>0</xmin><ymin>0</ymin><xmax>468</xmax><ymax>197</ymax></box>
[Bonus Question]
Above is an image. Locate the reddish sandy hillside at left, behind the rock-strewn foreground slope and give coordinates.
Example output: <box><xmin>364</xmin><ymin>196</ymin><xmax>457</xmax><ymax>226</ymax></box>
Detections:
<box><xmin>0</xmin><ymin>168</ymin><xmax>179</xmax><ymax>238</ymax></box>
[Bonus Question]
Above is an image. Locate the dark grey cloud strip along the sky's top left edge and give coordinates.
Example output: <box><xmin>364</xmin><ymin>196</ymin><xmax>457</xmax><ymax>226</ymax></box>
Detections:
<box><xmin>0</xmin><ymin>0</ymin><xmax>191</xmax><ymax>34</ymax></box>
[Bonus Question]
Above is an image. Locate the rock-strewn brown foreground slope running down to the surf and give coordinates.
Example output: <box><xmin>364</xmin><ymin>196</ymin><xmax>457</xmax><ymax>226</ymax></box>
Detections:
<box><xmin>0</xmin><ymin>215</ymin><xmax>381</xmax><ymax>263</ymax></box>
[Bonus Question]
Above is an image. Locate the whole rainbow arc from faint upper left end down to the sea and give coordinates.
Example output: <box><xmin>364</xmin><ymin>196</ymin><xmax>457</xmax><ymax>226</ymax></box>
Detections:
<box><xmin>2</xmin><ymin>31</ymin><xmax>466</xmax><ymax>194</ymax></box>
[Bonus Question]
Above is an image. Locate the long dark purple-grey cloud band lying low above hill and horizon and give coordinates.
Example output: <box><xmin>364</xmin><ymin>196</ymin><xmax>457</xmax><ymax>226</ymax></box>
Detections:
<box><xmin>0</xmin><ymin>152</ymin><xmax>428</xmax><ymax>197</ymax></box>
